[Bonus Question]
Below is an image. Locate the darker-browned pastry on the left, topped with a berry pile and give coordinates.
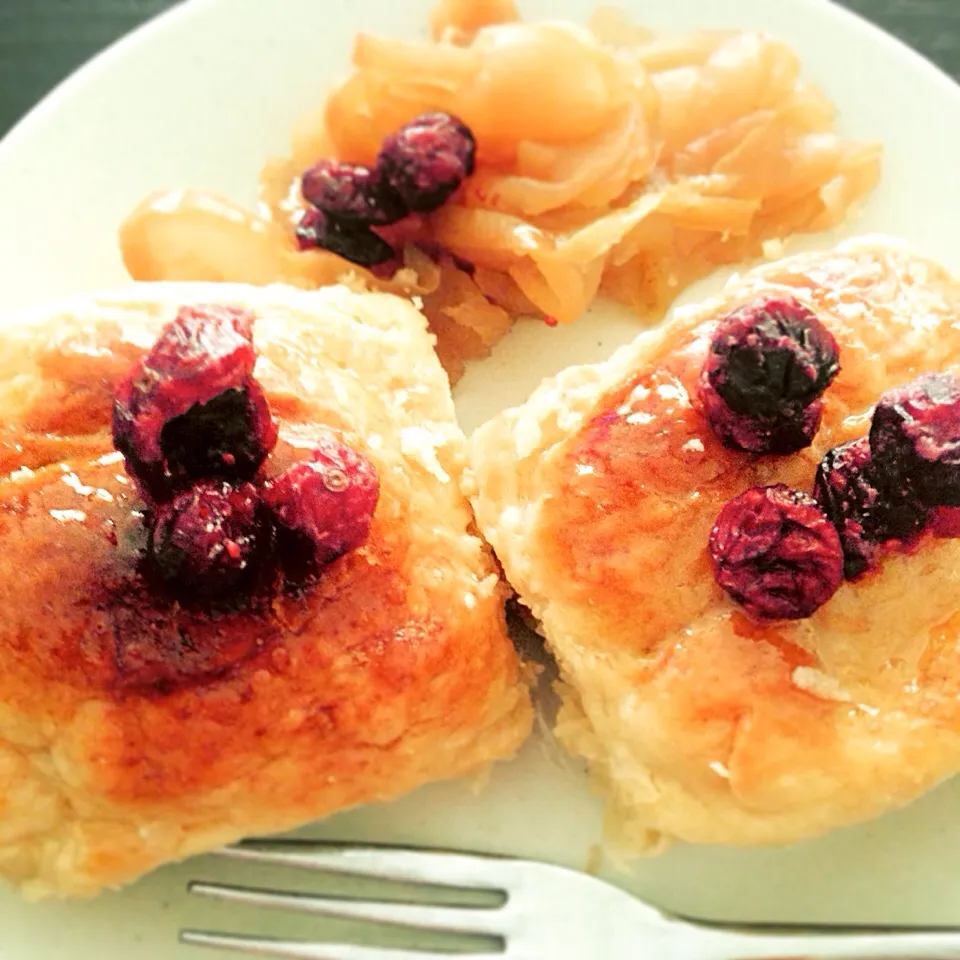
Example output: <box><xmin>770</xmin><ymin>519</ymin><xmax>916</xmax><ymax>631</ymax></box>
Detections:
<box><xmin>0</xmin><ymin>284</ymin><xmax>532</xmax><ymax>898</ymax></box>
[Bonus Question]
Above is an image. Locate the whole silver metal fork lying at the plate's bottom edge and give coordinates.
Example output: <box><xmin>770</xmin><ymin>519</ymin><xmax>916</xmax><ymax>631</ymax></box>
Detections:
<box><xmin>180</xmin><ymin>840</ymin><xmax>960</xmax><ymax>960</ymax></box>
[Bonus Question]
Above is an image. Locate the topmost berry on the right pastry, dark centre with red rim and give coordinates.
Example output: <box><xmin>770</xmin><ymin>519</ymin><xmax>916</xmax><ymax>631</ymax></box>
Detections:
<box><xmin>698</xmin><ymin>296</ymin><xmax>840</xmax><ymax>453</ymax></box>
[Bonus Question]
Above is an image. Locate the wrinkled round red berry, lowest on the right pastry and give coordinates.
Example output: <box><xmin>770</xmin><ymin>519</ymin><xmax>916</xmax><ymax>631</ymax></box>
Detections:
<box><xmin>709</xmin><ymin>484</ymin><xmax>843</xmax><ymax>620</ymax></box>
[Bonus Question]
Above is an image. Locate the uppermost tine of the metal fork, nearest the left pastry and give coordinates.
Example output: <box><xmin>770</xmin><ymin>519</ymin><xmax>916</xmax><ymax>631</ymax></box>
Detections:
<box><xmin>217</xmin><ymin>839</ymin><xmax>514</xmax><ymax>893</ymax></box>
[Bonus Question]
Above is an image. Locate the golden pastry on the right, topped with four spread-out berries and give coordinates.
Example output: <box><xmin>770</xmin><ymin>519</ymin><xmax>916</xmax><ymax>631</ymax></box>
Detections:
<box><xmin>471</xmin><ymin>237</ymin><xmax>960</xmax><ymax>850</ymax></box>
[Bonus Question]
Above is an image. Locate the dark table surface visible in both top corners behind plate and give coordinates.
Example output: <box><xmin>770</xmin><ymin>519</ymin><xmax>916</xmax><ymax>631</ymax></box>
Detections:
<box><xmin>0</xmin><ymin>0</ymin><xmax>960</xmax><ymax>136</ymax></box>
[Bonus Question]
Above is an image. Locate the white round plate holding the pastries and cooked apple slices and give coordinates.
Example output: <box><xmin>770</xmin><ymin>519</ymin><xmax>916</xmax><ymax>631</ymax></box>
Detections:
<box><xmin>0</xmin><ymin>0</ymin><xmax>960</xmax><ymax>960</ymax></box>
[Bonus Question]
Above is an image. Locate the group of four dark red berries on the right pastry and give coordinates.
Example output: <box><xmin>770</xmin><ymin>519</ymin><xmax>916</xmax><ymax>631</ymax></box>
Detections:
<box><xmin>698</xmin><ymin>297</ymin><xmax>960</xmax><ymax>619</ymax></box>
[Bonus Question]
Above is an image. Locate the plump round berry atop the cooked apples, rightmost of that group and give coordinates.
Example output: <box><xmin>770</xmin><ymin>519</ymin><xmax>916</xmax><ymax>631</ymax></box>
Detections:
<box><xmin>377</xmin><ymin>113</ymin><xmax>477</xmax><ymax>213</ymax></box>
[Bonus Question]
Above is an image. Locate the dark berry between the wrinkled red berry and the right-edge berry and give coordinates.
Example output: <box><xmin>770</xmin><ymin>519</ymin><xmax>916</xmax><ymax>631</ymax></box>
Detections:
<box><xmin>813</xmin><ymin>437</ymin><xmax>927</xmax><ymax>579</ymax></box>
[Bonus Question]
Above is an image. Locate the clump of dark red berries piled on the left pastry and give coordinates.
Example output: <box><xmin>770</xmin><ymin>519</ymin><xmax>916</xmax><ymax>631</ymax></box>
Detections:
<box><xmin>113</xmin><ymin>306</ymin><xmax>379</xmax><ymax>599</ymax></box>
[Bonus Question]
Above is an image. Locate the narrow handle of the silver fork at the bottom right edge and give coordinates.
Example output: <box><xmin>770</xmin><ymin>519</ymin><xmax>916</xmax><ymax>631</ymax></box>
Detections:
<box><xmin>691</xmin><ymin>930</ymin><xmax>960</xmax><ymax>960</ymax></box>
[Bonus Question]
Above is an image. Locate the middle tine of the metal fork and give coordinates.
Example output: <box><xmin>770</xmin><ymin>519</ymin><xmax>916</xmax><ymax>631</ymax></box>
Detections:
<box><xmin>187</xmin><ymin>882</ymin><xmax>503</xmax><ymax>936</ymax></box>
